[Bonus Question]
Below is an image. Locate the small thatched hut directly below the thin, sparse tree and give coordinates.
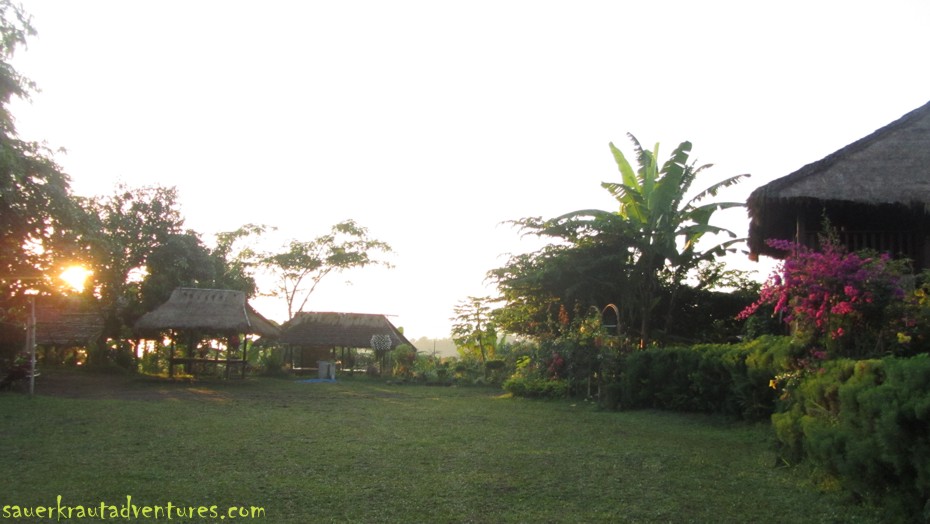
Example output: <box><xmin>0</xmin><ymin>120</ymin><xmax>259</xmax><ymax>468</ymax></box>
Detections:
<box><xmin>279</xmin><ymin>312</ymin><xmax>413</xmax><ymax>372</ymax></box>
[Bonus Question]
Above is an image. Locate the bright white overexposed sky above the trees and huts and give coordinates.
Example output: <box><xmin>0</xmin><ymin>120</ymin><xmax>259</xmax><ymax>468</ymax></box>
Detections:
<box><xmin>11</xmin><ymin>0</ymin><xmax>930</xmax><ymax>339</ymax></box>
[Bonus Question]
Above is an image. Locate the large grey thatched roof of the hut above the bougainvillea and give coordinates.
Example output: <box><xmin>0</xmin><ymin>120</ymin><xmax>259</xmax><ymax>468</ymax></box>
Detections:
<box><xmin>747</xmin><ymin>99</ymin><xmax>930</xmax><ymax>255</ymax></box>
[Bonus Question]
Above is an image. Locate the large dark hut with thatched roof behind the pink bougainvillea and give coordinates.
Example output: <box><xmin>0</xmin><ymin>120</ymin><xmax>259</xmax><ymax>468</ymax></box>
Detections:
<box><xmin>747</xmin><ymin>103</ymin><xmax>930</xmax><ymax>270</ymax></box>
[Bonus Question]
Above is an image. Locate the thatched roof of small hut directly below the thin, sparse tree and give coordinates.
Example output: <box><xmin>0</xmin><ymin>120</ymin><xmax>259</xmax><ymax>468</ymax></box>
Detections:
<box><xmin>280</xmin><ymin>312</ymin><xmax>413</xmax><ymax>348</ymax></box>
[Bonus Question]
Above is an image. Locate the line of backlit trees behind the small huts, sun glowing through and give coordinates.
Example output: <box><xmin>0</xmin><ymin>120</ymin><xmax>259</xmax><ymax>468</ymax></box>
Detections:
<box><xmin>0</xmin><ymin>0</ymin><xmax>391</xmax><ymax>363</ymax></box>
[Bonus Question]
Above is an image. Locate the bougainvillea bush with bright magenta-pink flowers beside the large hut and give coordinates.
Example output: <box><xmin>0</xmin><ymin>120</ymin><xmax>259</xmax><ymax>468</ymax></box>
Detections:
<box><xmin>740</xmin><ymin>240</ymin><xmax>907</xmax><ymax>357</ymax></box>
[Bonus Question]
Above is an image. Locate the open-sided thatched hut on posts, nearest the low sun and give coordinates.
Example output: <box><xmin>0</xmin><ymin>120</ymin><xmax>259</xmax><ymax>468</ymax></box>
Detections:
<box><xmin>134</xmin><ymin>288</ymin><xmax>280</xmax><ymax>377</ymax></box>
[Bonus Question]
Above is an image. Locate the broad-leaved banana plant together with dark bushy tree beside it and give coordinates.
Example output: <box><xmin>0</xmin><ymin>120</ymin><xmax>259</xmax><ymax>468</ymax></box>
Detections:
<box><xmin>489</xmin><ymin>135</ymin><xmax>748</xmax><ymax>346</ymax></box>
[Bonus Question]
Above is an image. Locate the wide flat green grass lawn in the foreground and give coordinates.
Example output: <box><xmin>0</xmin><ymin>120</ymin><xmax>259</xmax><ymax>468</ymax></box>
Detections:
<box><xmin>0</xmin><ymin>374</ymin><xmax>880</xmax><ymax>523</ymax></box>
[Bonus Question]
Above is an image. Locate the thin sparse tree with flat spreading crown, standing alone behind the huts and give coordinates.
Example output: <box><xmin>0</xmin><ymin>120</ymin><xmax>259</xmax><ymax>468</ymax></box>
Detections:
<box><xmin>258</xmin><ymin>220</ymin><xmax>391</xmax><ymax>319</ymax></box>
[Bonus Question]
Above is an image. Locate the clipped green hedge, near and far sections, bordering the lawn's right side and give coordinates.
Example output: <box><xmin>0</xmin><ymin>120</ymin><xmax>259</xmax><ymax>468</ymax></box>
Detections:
<box><xmin>606</xmin><ymin>336</ymin><xmax>930</xmax><ymax>522</ymax></box>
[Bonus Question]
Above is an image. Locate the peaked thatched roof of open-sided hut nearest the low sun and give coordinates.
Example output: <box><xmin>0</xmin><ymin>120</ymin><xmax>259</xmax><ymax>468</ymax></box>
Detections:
<box><xmin>135</xmin><ymin>288</ymin><xmax>279</xmax><ymax>336</ymax></box>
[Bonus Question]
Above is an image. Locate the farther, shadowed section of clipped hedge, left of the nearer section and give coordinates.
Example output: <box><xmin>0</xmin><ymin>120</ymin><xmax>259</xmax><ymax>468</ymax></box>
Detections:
<box><xmin>606</xmin><ymin>336</ymin><xmax>792</xmax><ymax>420</ymax></box>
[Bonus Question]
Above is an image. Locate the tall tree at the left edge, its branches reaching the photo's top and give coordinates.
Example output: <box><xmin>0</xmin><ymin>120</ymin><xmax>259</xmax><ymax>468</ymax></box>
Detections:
<box><xmin>0</xmin><ymin>0</ymin><xmax>81</xmax><ymax>297</ymax></box>
